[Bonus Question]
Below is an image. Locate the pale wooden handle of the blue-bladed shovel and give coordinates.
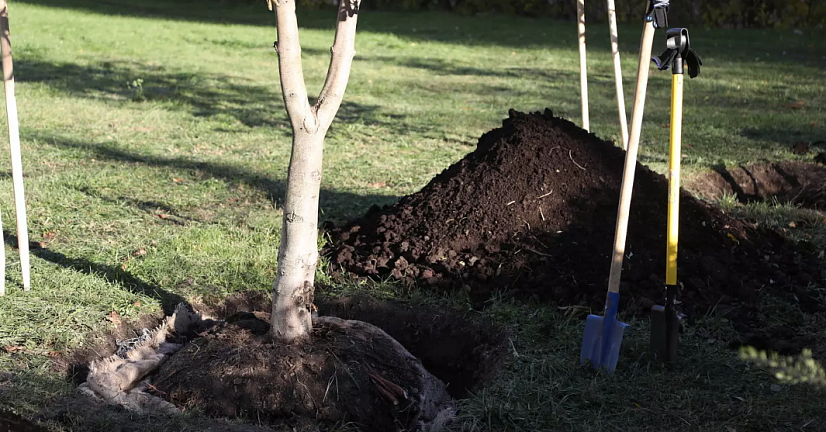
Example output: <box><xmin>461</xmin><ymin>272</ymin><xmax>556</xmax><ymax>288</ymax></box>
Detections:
<box><xmin>608</xmin><ymin>21</ymin><xmax>655</xmax><ymax>293</ymax></box>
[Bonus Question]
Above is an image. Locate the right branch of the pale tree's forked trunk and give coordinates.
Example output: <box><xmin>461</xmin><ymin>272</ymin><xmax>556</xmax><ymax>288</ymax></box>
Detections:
<box><xmin>315</xmin><ymin>0</ymin><xmax>361</xmax><ymax>131</ymax></box>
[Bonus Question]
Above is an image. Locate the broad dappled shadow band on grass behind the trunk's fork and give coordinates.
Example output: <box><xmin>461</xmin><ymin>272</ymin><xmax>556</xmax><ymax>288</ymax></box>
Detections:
<box><xmin>16</xmin><ymin>57</ymin><xmax>440</xmax><ymax>135</ymax></box>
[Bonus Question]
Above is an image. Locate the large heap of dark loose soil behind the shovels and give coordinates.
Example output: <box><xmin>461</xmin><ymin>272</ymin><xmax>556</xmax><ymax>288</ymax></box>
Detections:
<box><xmin>325</xmin><ymin>110</ymin><xmax>824</xmax><ymax>344</ymax></box>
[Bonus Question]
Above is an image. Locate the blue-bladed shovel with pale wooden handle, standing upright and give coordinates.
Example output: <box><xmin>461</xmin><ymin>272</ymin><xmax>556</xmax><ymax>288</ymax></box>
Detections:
<box><xmin>579</xmin><ymin>0</ymin><xmax>668</xmax><ymax>372</ymax></box>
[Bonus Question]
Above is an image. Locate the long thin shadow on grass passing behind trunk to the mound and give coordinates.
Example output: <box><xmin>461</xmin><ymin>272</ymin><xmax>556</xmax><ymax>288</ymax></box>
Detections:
<box><xmin>25</xmin><ymin>133</ymin><xmax>398</xmax><ymax>223</ymax></box>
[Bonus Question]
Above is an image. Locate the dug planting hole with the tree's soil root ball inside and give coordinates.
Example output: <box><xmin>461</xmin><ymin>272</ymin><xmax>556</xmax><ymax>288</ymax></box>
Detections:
<box><xmin>42</xmin><ymin>292</ymin><xmax>506</xmax><ymax>431</ymax></box>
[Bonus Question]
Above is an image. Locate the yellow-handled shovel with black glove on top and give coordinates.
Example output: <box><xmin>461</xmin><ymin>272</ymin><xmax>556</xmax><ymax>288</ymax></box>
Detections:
<box><xmin>651</xmin><ymin>28</ymin><xmax>703</xmax><ymax>363</ymax></box>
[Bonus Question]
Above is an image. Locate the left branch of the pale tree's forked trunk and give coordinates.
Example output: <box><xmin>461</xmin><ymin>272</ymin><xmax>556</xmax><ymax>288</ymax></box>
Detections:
<box><xmin>273</xmin><ymin>0</ymin><xmax>318</xmax><ymax>133</ymax></box>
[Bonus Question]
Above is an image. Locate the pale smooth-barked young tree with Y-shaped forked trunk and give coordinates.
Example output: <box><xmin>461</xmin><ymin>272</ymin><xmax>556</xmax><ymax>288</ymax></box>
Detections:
<box><xmin>268</xmin><ymin>0</ymin><xmax>361</xmax><ymax>342</ymax></box>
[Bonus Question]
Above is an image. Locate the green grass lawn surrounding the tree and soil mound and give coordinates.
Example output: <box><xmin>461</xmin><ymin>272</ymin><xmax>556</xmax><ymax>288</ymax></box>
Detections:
<box><xmin>0</xmin><ymin>0</ymin><xmax>826</xmax><ymax>432</ymax></box>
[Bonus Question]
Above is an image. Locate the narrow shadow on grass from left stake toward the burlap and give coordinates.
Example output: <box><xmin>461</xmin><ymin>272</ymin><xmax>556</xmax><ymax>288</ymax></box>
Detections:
<box><xmin>3</xmin><ymin>230</ymin><xmax>184</xmax><ymax>314</ymax></box>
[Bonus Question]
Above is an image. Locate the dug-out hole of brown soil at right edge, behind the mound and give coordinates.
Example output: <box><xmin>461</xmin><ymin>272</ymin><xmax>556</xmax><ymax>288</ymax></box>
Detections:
<box><xmin>686</xmin><ymin>161</ymin><xmax>826</xmax><ymax>210</ymax></box>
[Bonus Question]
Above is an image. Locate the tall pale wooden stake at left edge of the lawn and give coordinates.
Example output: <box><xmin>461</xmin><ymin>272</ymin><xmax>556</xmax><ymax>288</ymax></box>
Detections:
<box><xmin>0</xmin><ymin>0</ymin><xmax>31</xmax><ymax>291</ymax></box>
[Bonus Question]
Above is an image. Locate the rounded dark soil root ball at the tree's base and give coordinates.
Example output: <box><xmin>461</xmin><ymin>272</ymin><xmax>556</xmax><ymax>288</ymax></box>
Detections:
<box><xmin>154</xmin><ymin>313</ymin><xmax>446</xmax><ymax>431</ymax></box>
